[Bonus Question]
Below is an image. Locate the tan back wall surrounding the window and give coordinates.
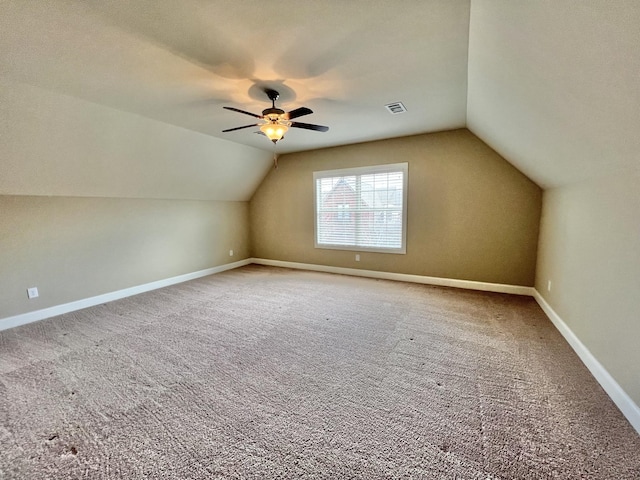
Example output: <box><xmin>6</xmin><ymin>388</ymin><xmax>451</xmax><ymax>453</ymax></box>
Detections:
<box><xmin>250</xmin><ymin>129</ymin><xmax>542</xmax><ymax>286</ymax></box>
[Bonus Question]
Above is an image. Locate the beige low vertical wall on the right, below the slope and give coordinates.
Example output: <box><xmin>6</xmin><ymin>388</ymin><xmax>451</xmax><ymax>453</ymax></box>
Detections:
<box><xmin>536</xmin><ymin>172</ymin><xmax>640</xmax><ymax>405</ymax></box>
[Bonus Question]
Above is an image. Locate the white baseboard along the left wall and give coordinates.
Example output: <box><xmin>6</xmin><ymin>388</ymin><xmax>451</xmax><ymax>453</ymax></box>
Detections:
<box><xmin>0</xmin><ymin>259</ymin><xmax>251</xmax><ymax>330</ymax></box>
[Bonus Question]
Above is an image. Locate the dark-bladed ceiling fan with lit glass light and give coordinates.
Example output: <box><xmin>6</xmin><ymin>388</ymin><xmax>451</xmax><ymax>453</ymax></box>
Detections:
<box><xmin>222</xmin><ymin>88</ymin><xmax>329</xmax><ymax>143</ymax></box>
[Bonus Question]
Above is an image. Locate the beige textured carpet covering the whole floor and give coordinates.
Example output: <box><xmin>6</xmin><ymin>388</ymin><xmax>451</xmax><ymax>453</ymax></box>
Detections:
<box><xmin>0</xmin><ymin>266</ymin><xmax>640</xmax><ymax>480</ymax></box>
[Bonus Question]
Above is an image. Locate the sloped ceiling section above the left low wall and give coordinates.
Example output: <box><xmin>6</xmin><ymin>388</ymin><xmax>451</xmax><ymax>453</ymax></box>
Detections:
<box><xmin>0</xmin><ymin>81</ymin><xmax>272</xmax><ymax>201</ymax></box>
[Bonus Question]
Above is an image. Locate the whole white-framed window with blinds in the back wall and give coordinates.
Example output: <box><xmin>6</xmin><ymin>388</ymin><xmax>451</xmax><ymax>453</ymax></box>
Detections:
<box><xmin>313</xmin><ymin>163</ymin><xmax>408</xmax><ymax>253</ymax></box>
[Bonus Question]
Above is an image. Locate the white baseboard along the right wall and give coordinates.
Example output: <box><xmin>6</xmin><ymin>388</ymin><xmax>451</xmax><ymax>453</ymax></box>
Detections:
<box><xmin>533</xmin><ymin>289</ymin><xmax>640</xmax><ymax>434</ymax></box>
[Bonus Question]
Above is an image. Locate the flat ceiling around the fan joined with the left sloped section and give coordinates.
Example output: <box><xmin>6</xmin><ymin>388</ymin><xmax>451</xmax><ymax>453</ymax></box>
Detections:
<box><xmin>0</xmin><ymin>0</ymin><xmax>470</xmax><ymax>200</ymax></box>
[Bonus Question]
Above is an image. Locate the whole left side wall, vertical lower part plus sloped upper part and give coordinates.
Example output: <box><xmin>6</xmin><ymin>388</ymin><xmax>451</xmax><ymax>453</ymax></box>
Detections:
<box><xmin>0</xmin><ymin>76</ymin><xmax>264</xmax><ymax>319</ymax></box>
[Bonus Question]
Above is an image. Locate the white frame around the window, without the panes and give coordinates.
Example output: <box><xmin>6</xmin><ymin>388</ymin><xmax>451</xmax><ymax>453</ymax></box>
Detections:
<box><xmin>313</xmin><ymin>162</ymin><xmax>409</xmax><ymax>255</ymax></box>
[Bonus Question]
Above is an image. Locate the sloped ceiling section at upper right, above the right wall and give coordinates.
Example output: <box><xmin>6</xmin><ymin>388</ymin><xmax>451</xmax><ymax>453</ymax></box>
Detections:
<box><xmin>467</xmin><ymin>0</ymin><xmax>640</xmax><ymax>188</ymax></box>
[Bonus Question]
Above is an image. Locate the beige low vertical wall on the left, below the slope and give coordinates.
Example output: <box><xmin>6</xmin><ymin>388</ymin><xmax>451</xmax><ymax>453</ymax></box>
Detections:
<box><xmin>0</xmin><ymin>196</ymin><xmax>250</xmax><ymax>319</ymax></box>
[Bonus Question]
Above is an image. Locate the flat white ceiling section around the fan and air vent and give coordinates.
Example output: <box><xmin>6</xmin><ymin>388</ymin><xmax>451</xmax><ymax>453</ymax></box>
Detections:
<box><xmin>0</xmin><ymin>0</ymin><xmax>469</xmax><ymax>153</ymax></box>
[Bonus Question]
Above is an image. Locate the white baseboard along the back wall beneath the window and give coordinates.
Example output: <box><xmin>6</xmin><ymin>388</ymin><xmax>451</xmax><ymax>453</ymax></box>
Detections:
<box><xmin>251</xmin><ymin>258</ymin><xmax>535</xmax><ymax>296</ymax></box>
